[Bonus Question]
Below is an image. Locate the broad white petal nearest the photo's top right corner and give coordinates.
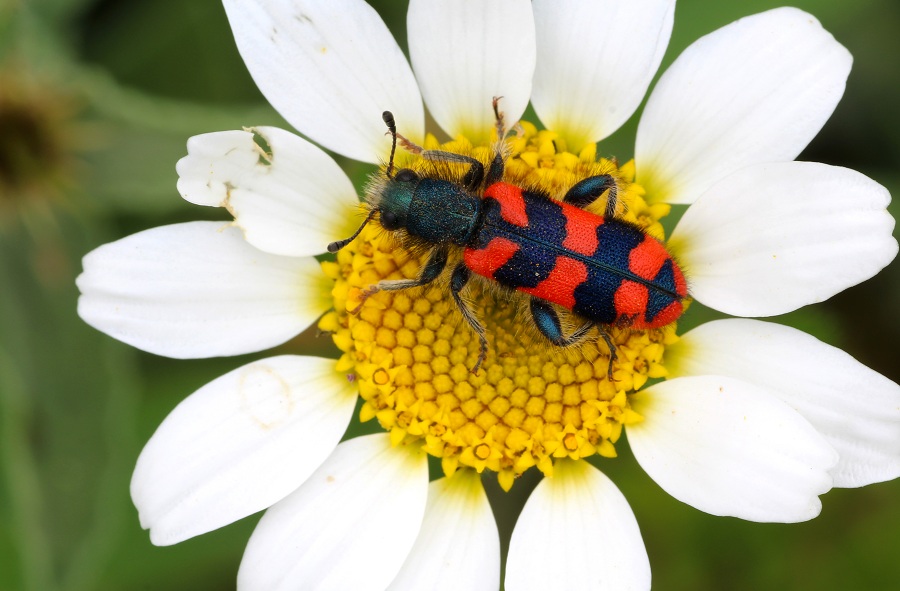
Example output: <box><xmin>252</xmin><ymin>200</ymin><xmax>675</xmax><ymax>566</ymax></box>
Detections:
<box><xmin>635</xmin><ymin>8</ymin><xmax>853</xmax><ymax>203</ymax></box>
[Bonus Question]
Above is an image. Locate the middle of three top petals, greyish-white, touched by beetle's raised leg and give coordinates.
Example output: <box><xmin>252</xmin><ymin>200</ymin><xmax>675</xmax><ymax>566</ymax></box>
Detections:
<box><xmin>407</xmin><ymin>0</ymin><xmax>535</xmax><ymax>142</ymax></box>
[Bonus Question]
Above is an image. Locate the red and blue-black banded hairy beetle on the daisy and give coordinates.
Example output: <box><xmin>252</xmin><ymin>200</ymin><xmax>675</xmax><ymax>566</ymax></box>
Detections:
<box><xmin>328</xmin><ymin>98</ymin><xmax>687</xmax><ymax>380</ymax></box>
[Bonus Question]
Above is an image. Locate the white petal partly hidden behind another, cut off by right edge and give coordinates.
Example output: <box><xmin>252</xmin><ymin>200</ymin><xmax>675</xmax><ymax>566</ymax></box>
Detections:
<box><xmin>666</xmin><ymin>319</ymin><xmax>900</xmax><ymax>487</ymax></box>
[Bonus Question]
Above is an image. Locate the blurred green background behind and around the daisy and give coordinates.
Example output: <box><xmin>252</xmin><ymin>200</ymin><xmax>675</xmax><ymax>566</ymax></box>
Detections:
<box><xmin>0</xmin><ymin>0</ymin><xmax>900</xmax><ymax>591</ymax></box>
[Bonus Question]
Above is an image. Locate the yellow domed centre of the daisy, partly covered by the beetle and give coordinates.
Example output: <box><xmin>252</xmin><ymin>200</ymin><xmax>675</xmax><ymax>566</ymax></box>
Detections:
<box><xmin>319</xmin><ymin>122</ymin><xmax>676</xmax><ymax>490</ymax></box>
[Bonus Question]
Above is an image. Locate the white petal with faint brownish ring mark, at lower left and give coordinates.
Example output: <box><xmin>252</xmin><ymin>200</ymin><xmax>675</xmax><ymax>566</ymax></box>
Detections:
<box><xmin>131</xmin><ymin>355</ymin><xmax>356</xmax><ymax>546</ymax></box>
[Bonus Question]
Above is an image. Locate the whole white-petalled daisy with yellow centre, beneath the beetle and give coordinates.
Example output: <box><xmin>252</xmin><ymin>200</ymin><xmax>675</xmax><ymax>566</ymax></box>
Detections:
<box><xmin>78</xmin><ymin>0</ymin><xmax>900</xmax><ymax>591</ymax></box>
